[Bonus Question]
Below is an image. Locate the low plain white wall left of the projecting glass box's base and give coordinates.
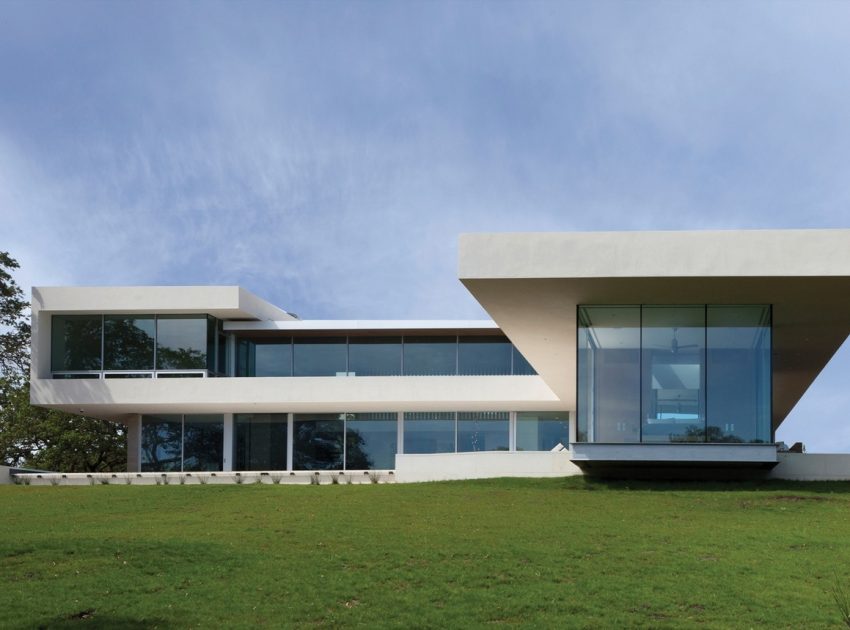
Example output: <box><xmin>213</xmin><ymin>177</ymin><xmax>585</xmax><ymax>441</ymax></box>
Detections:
<box><xmin>395</xmin><ymin>451</ymin><xmax>581</xmax><ymax>483</ymax></box>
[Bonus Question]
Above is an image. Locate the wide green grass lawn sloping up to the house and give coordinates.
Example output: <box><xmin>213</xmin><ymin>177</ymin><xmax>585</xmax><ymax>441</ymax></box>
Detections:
<box><xmin>0</xmin><ymin>478</ymin><xmax>850</xmax><ymax>628</ymax></box>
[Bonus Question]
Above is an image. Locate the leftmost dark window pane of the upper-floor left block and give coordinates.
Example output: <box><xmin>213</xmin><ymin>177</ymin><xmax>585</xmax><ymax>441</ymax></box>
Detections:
<box><xmin>50</xmin><ymin>315</ymin><xmax>103</xmax><ymax>372</ymax></box>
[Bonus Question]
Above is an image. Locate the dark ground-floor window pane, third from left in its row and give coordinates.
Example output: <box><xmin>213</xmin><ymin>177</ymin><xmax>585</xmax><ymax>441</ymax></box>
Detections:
<box><xmin>233</xmin><ymin>413</ymin><xmax>286</xmax><ymax>470</ymax></box>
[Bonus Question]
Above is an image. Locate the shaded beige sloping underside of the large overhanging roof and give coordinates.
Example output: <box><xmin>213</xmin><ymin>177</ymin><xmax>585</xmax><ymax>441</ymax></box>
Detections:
<box><xmin>462</xmin><ymin>276</ymin><xmax>850</xmax><ymax>429</ymax></box>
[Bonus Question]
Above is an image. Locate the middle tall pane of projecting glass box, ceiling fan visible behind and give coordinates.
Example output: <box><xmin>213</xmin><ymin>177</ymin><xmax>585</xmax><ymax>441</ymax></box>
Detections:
<box><xmin>641</xmin><ymin>306</ymin><xmax>705</xmax><ymax>442</ymax></box>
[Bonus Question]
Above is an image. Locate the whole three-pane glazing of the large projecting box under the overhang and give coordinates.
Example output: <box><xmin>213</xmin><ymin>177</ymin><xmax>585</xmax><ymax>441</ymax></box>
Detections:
<box><xmin>577</xmin><ymin>305</ymin><xmax>771</xmax><ymax>443</ymax></box>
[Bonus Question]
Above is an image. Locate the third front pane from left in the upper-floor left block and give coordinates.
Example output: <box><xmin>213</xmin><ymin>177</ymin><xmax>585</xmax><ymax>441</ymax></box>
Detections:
<box><xmin>156</xmin><ymin>315</ymin><xmax>207</xmax><ymax>370</ymax></box>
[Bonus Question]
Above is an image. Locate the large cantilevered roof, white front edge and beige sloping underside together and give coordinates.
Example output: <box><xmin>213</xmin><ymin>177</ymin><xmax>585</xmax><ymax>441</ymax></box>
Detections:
<box><xmin>459</xmin><ymin>229</ymin><xmax>850</xmax><ymax>429</ymax></box>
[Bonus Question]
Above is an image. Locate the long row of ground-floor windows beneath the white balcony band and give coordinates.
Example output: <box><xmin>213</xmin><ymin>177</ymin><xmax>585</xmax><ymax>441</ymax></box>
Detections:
<box><xmin>140</xmin><ymin>411</ymin><xmax>569</xmax><ymax>472</ymax></box>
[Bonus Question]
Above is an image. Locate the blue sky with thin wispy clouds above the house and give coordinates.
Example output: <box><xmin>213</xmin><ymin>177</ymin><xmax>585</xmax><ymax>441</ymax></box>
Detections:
<box><xmin>0</xmin><ymin>0</ymin><xmax>850</xmax><ymax>452</ymax></box>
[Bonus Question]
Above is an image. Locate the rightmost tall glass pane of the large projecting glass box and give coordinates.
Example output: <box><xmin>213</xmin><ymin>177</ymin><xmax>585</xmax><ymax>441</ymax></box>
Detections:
<box><xmin>706</xmin><ymin>306</ymin><xmax>771</xmax><ymax>442</ymax></box>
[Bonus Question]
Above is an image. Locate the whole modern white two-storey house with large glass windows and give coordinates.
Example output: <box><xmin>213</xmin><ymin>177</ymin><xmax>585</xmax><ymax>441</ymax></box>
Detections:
<box><xmin>24</xmin><ymin>230</ymin><xmax>850</xmax><ymax>481</ymax></box>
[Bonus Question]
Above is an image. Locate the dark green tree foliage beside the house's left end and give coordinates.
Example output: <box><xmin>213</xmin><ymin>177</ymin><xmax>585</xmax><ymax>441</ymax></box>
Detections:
<box><xmin>0</xmin><ymin>252</ymin><xmax>127</xmax><ymax>472</ymax></box>
